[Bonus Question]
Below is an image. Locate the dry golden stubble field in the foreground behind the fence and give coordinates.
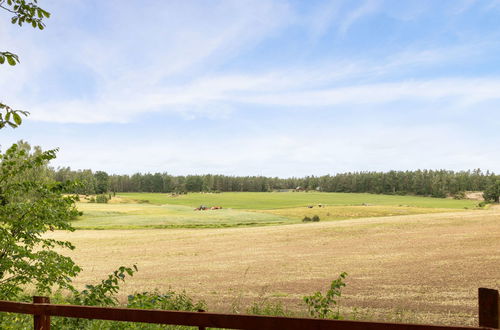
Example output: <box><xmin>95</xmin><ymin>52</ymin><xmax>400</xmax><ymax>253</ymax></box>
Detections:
<box><xmin>47</xmin><ymin>208</ymin><xmax>500</xmax><ymax>325</ymax></box>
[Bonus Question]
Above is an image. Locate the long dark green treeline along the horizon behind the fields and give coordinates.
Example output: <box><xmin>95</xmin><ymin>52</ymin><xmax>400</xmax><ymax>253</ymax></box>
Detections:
<box><xmin>52</xmin><ymin>167</ymin><xmax>500</xmax><ymax>197</ymax></box>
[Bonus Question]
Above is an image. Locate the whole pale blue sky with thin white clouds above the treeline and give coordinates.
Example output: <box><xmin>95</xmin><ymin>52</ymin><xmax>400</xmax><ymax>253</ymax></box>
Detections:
<box><xmin>0</xmin><ymin>0</ymin><xmax>500</xmax><ymax>177</ymax></box>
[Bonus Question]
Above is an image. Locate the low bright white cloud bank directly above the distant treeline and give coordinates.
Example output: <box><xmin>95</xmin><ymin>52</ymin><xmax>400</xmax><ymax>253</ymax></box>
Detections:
<box><xmin>34</xmin><ymin>122</ymin><xmax>500</xmax><ymax>177</ymax></box>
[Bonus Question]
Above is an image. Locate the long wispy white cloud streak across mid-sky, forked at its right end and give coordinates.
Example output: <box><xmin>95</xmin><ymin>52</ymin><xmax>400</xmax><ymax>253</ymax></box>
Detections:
<box><xmin>21</xmin><ymin>40</ymin><xmax>500</xmax><ymax>123</ymax></box>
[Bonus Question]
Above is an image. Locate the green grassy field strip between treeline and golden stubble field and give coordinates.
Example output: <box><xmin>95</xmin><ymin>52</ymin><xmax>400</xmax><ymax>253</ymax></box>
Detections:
<box><xmin>73</xmin><ymin>192</ymin><xmax>476</xmax><ymax>229</ymax></box>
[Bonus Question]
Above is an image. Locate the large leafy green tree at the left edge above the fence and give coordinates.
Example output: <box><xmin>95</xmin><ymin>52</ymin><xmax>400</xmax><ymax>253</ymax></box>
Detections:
<box><xmin>0</xmin><ymin>144</ymin><xmax>80</xmax><ymax>298</ymax></box>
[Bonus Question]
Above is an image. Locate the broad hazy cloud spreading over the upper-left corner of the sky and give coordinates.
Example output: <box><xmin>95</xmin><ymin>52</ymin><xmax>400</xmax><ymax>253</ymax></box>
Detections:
<box><xmin>0</xmin><ymin>1</ymin><xmax>291</xmax><ymax>123</ymax></box>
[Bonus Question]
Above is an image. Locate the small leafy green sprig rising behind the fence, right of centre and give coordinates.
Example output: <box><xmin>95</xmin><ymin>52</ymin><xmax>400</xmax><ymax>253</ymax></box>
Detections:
<box><xmin>303</xmin><ymin>272</ymin><xmax>347</xmax><ymax>319</ymax></box>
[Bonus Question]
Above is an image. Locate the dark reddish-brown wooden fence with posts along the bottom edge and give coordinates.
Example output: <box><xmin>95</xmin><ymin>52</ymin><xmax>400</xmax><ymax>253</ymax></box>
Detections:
<box><xmin>0</xmin><ymin>288</ymin><xmax>500</xmax><ymax>330</ymax></box>
